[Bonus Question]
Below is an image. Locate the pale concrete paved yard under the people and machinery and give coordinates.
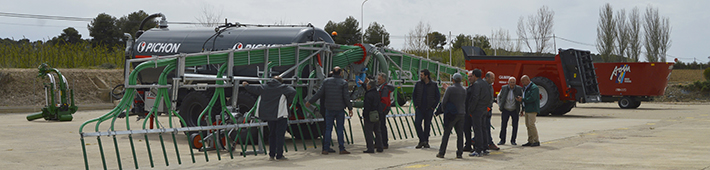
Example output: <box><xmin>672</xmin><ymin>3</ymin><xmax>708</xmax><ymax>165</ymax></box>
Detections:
<box><xmin>0</xmin><ymin>103</ymin><xmax>710</xmax><ymax>170</ymax></box>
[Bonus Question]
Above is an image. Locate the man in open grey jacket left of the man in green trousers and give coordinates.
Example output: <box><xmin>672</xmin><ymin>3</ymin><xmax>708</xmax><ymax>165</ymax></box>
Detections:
<box><xmin>498</xmin><ymin>77</ymin><xmax>523</xmax><ymax>145</ymax></box>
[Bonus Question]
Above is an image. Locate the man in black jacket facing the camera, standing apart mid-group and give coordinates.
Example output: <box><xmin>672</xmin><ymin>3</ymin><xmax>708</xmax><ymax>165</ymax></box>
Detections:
<box><xmin>412</xmin><ymin>69</ymin><xmax>441</xmax><ymax>149</ymax></box>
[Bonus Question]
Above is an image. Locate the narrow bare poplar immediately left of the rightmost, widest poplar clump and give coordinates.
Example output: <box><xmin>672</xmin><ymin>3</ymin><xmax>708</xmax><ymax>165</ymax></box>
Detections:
<box><xmin>626</xmin><ymin>8</ymin><xmax>641</xmax><ymax>62</ymax></box>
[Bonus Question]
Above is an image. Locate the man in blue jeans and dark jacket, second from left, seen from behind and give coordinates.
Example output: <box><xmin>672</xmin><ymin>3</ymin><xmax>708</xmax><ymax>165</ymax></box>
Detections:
<box><xmin>306</xmin><ymin>66</ymin><xmax>353</xmax><ymax>155</ymax></box>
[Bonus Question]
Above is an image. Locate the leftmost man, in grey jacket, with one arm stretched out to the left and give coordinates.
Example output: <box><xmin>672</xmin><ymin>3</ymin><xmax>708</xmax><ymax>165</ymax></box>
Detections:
<box><xmin>242</xmin><ymin>76</ymin><xmax>296</xmax><ymax>160</ymax></box>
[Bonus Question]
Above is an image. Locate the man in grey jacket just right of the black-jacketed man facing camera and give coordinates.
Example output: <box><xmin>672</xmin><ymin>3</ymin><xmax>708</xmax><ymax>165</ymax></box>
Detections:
<box><xmin>436</xmin><ymin>73</ymin><xmax>466</xmax><ymax>158</ymax></box>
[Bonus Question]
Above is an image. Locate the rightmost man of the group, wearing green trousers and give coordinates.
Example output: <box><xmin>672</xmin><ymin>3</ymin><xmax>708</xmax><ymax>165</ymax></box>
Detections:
<box><xmin>520</xmin><ymin>75</ymin><xmax>540</xmax><ymax>147</ymax></box>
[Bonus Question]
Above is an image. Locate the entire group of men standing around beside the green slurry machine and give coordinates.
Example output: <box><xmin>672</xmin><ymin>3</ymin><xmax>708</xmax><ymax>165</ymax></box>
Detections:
<box><xmin>243</xmin><ymin>67</ymin><xmax>540</xmax><ymax>160</ymax></box>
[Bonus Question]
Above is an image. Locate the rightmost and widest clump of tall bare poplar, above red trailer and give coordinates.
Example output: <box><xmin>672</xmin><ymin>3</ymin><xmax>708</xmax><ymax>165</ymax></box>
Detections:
<box><xmin>643</xmin><ymin>6</ymin><xmax>671</xmax><ymax>62</ymax></box>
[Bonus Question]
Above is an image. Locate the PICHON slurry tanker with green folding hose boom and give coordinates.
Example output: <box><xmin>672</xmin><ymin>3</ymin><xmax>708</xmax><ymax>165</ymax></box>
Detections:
<box><xmin>80</xmin><ymin>14</ymin><xmax>464</xmax><ymax>169</ymax></box>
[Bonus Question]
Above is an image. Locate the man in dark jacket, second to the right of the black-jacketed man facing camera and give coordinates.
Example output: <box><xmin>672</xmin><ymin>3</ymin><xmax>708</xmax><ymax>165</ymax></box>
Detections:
<box><xmin>466</xmin><ymin>69</ymin><xmax>493</xmax><ymax>156</ymax></box>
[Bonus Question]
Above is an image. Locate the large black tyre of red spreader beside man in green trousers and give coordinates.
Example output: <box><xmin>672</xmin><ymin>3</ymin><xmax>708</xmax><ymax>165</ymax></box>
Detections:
<box><xmin>530</xmin><ymin>77</ymin><xmax>560</xmax><ymax>116</ymax></box>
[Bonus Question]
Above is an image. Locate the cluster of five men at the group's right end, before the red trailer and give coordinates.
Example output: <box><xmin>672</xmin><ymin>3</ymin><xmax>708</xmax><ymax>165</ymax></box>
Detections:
<box><xmin>434</xmin><ymin>69</ymin><xmax>540</xmax><ymax>158</ymax></box>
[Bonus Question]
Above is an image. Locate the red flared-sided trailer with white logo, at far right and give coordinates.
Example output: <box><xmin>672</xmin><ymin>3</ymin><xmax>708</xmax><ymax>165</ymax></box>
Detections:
<box><xmin>594</xmin><ymin>62</ymin><xmax>674</xmax><ymax>109</ymax></box>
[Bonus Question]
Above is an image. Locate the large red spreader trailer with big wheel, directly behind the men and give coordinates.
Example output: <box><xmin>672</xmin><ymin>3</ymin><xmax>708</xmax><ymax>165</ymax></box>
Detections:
<box><xmin>463</xmin><ymin>46</ymin><xmax>601</xmax><ymax>115</ymax></box>
